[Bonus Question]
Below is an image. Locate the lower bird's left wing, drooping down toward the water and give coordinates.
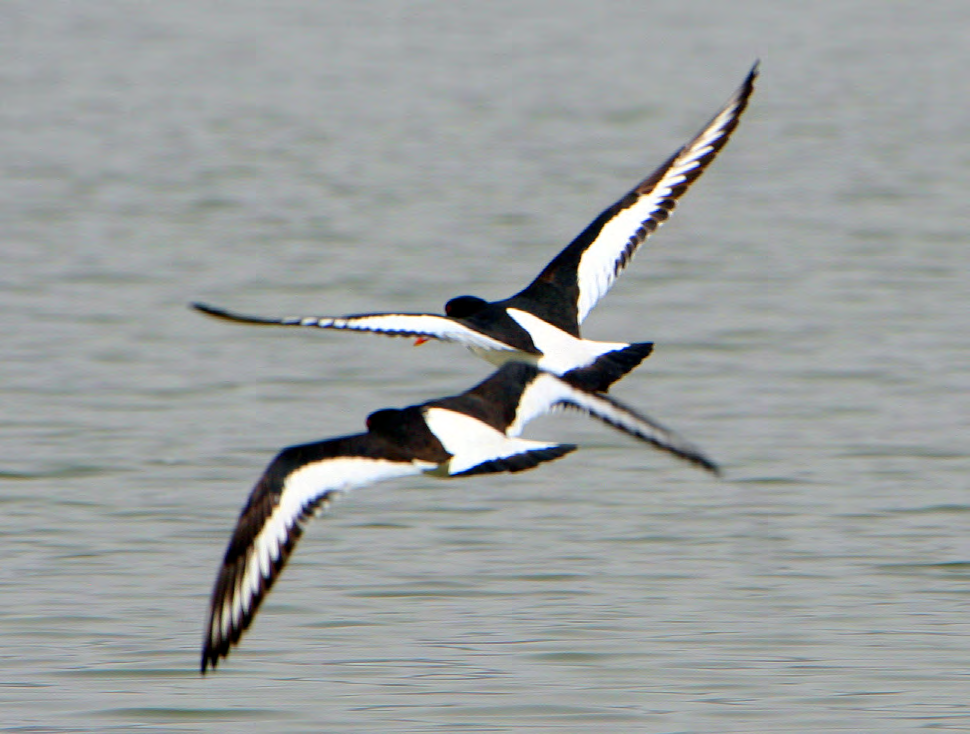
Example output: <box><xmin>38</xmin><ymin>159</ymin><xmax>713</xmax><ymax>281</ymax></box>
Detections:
<box><xmin>202</xmin><ymin>434</ymin><xmax>435</xmax><ymax>673</ymax></box>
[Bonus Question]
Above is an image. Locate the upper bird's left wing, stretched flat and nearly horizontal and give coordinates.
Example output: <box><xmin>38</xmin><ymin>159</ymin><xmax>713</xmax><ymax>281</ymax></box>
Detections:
<box><xmin>192</xmin><ymin>303</ymin><xmax>514</xmax><ymax>358</ymax></box>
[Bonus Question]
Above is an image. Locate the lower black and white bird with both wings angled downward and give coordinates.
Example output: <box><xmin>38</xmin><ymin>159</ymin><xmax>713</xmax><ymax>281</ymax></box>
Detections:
<box><xmin>202</xmin><ymin>362</ymin><xmax>718</xmax><ymax>673</ymax></box>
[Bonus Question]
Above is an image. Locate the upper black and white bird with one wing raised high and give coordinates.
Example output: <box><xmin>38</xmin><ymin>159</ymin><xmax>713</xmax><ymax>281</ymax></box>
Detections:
<box><xmin>193</xmin><ymin>64</ymin><xmax>758</xmax><ymax>391</ymax></box>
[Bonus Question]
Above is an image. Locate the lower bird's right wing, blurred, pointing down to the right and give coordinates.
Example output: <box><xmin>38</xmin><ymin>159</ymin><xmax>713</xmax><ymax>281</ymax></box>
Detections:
<box><xmin>507</xmin><ymin>372</ymin><xmax>720</xmax><ymax>474</ymax></box>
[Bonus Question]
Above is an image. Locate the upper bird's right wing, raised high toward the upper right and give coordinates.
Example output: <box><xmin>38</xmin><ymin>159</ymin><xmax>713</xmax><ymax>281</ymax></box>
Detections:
<box><xmin>509</xmin><ymin>64</ymin><xmax>758</xmax><ymax>328</ymax></box>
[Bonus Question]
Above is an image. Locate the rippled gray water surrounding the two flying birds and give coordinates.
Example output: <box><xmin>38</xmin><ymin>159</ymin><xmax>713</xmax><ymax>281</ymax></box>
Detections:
<box><xmin>0</xmin><ymin>0</ymin><xmax>970</xmax><ymax>732</ymax></box>
